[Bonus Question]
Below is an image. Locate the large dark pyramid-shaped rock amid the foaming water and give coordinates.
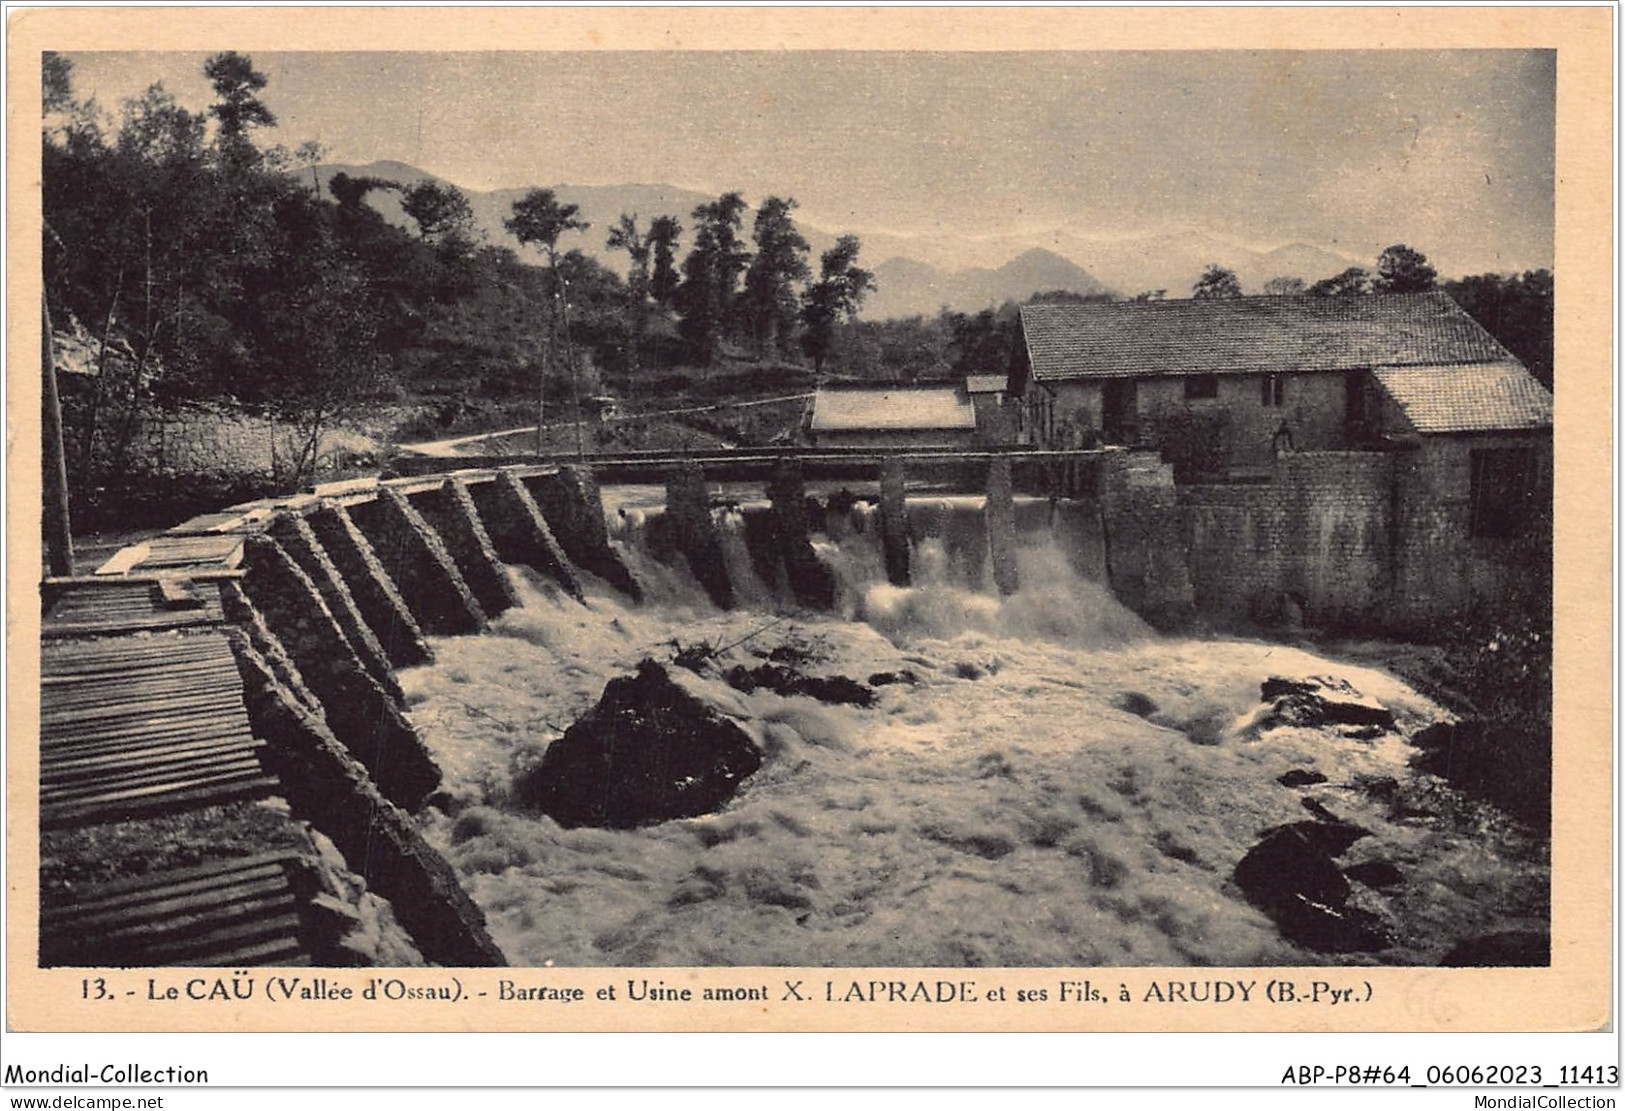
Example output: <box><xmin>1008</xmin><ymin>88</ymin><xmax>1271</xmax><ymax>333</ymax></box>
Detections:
<box><xmin>514</xmin><ymin>659</ymin><xmax>762</xmax><ymax>828</ymax></box>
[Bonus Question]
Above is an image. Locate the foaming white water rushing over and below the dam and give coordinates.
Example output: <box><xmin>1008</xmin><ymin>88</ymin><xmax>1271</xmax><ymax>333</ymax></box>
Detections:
<box><xmin>401</xmin><ymin>504</ymin><xmax>1549</xmax><ymax>966</ymax></box>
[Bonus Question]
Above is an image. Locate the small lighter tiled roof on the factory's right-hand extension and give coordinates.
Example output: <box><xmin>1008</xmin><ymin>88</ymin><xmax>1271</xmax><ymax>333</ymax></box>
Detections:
<box><xmin>1373</xmin><ymin>362</ymin><xmax>1552</xmax><ymax>432</ymax></box>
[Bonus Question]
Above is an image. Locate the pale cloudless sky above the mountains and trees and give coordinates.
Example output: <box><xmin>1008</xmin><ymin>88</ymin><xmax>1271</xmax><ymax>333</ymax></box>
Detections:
<box><xmin>68</xmin><ymin>50</ymin><xmax>1557</xmax><ymax>275</ymax></box>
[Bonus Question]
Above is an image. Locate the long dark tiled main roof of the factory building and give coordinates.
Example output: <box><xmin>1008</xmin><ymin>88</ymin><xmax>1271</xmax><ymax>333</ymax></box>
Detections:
<box><xmin>1021</xmin><ymin>292</ymin><xmax>1511</xmax><ymax>382</ymax></box>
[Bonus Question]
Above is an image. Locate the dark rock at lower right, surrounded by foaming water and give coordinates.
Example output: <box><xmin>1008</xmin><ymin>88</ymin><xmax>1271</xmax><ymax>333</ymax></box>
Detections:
<box><xmin>1235</xmin><ymin>822</ymin><xmax>1391</xmax><ymax>953</ymax></box>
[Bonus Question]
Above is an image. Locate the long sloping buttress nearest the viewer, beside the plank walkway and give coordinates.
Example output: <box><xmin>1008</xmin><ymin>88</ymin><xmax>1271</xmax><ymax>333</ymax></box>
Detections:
<box><xmin>229</xmin><ymin>630</ymin><xmax>507</xmax><ymax>968</ymax></box>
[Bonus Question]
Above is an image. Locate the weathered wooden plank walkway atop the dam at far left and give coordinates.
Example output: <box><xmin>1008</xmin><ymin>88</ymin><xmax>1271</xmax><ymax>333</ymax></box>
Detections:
<box><xmin>39</xmin><ymin>512</ymin><xmax>312</xmax><ymax>968</ymax></box>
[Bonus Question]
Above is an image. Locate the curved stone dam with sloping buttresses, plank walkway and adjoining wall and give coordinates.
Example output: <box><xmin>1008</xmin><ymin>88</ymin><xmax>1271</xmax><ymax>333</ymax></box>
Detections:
<box><xmin>39</xmin><ymin>450</ymin><xmax>1540</xmax><ymax>966</ymax></box>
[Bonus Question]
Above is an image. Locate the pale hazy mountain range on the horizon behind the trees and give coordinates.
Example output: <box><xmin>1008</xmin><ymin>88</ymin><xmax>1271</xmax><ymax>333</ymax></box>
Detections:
<box><xmin>315</xmin><ymin>161</ymin><xmax>1373</xmax><ymax>320</ymax></box>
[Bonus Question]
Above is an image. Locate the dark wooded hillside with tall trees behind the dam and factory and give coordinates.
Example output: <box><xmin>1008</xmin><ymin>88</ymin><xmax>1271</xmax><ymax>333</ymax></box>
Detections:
<box><xmin>42</xmin><ymin>52</ymin><xmax>1552</xmax><ymax>529</ymax></box>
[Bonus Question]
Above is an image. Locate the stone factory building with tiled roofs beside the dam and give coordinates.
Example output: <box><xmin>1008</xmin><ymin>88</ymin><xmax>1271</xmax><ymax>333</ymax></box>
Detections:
<box><xmin>1009</xmin><ymin>292</ymin><xmax>1552</xmax><ymax>632</ymax></box>
